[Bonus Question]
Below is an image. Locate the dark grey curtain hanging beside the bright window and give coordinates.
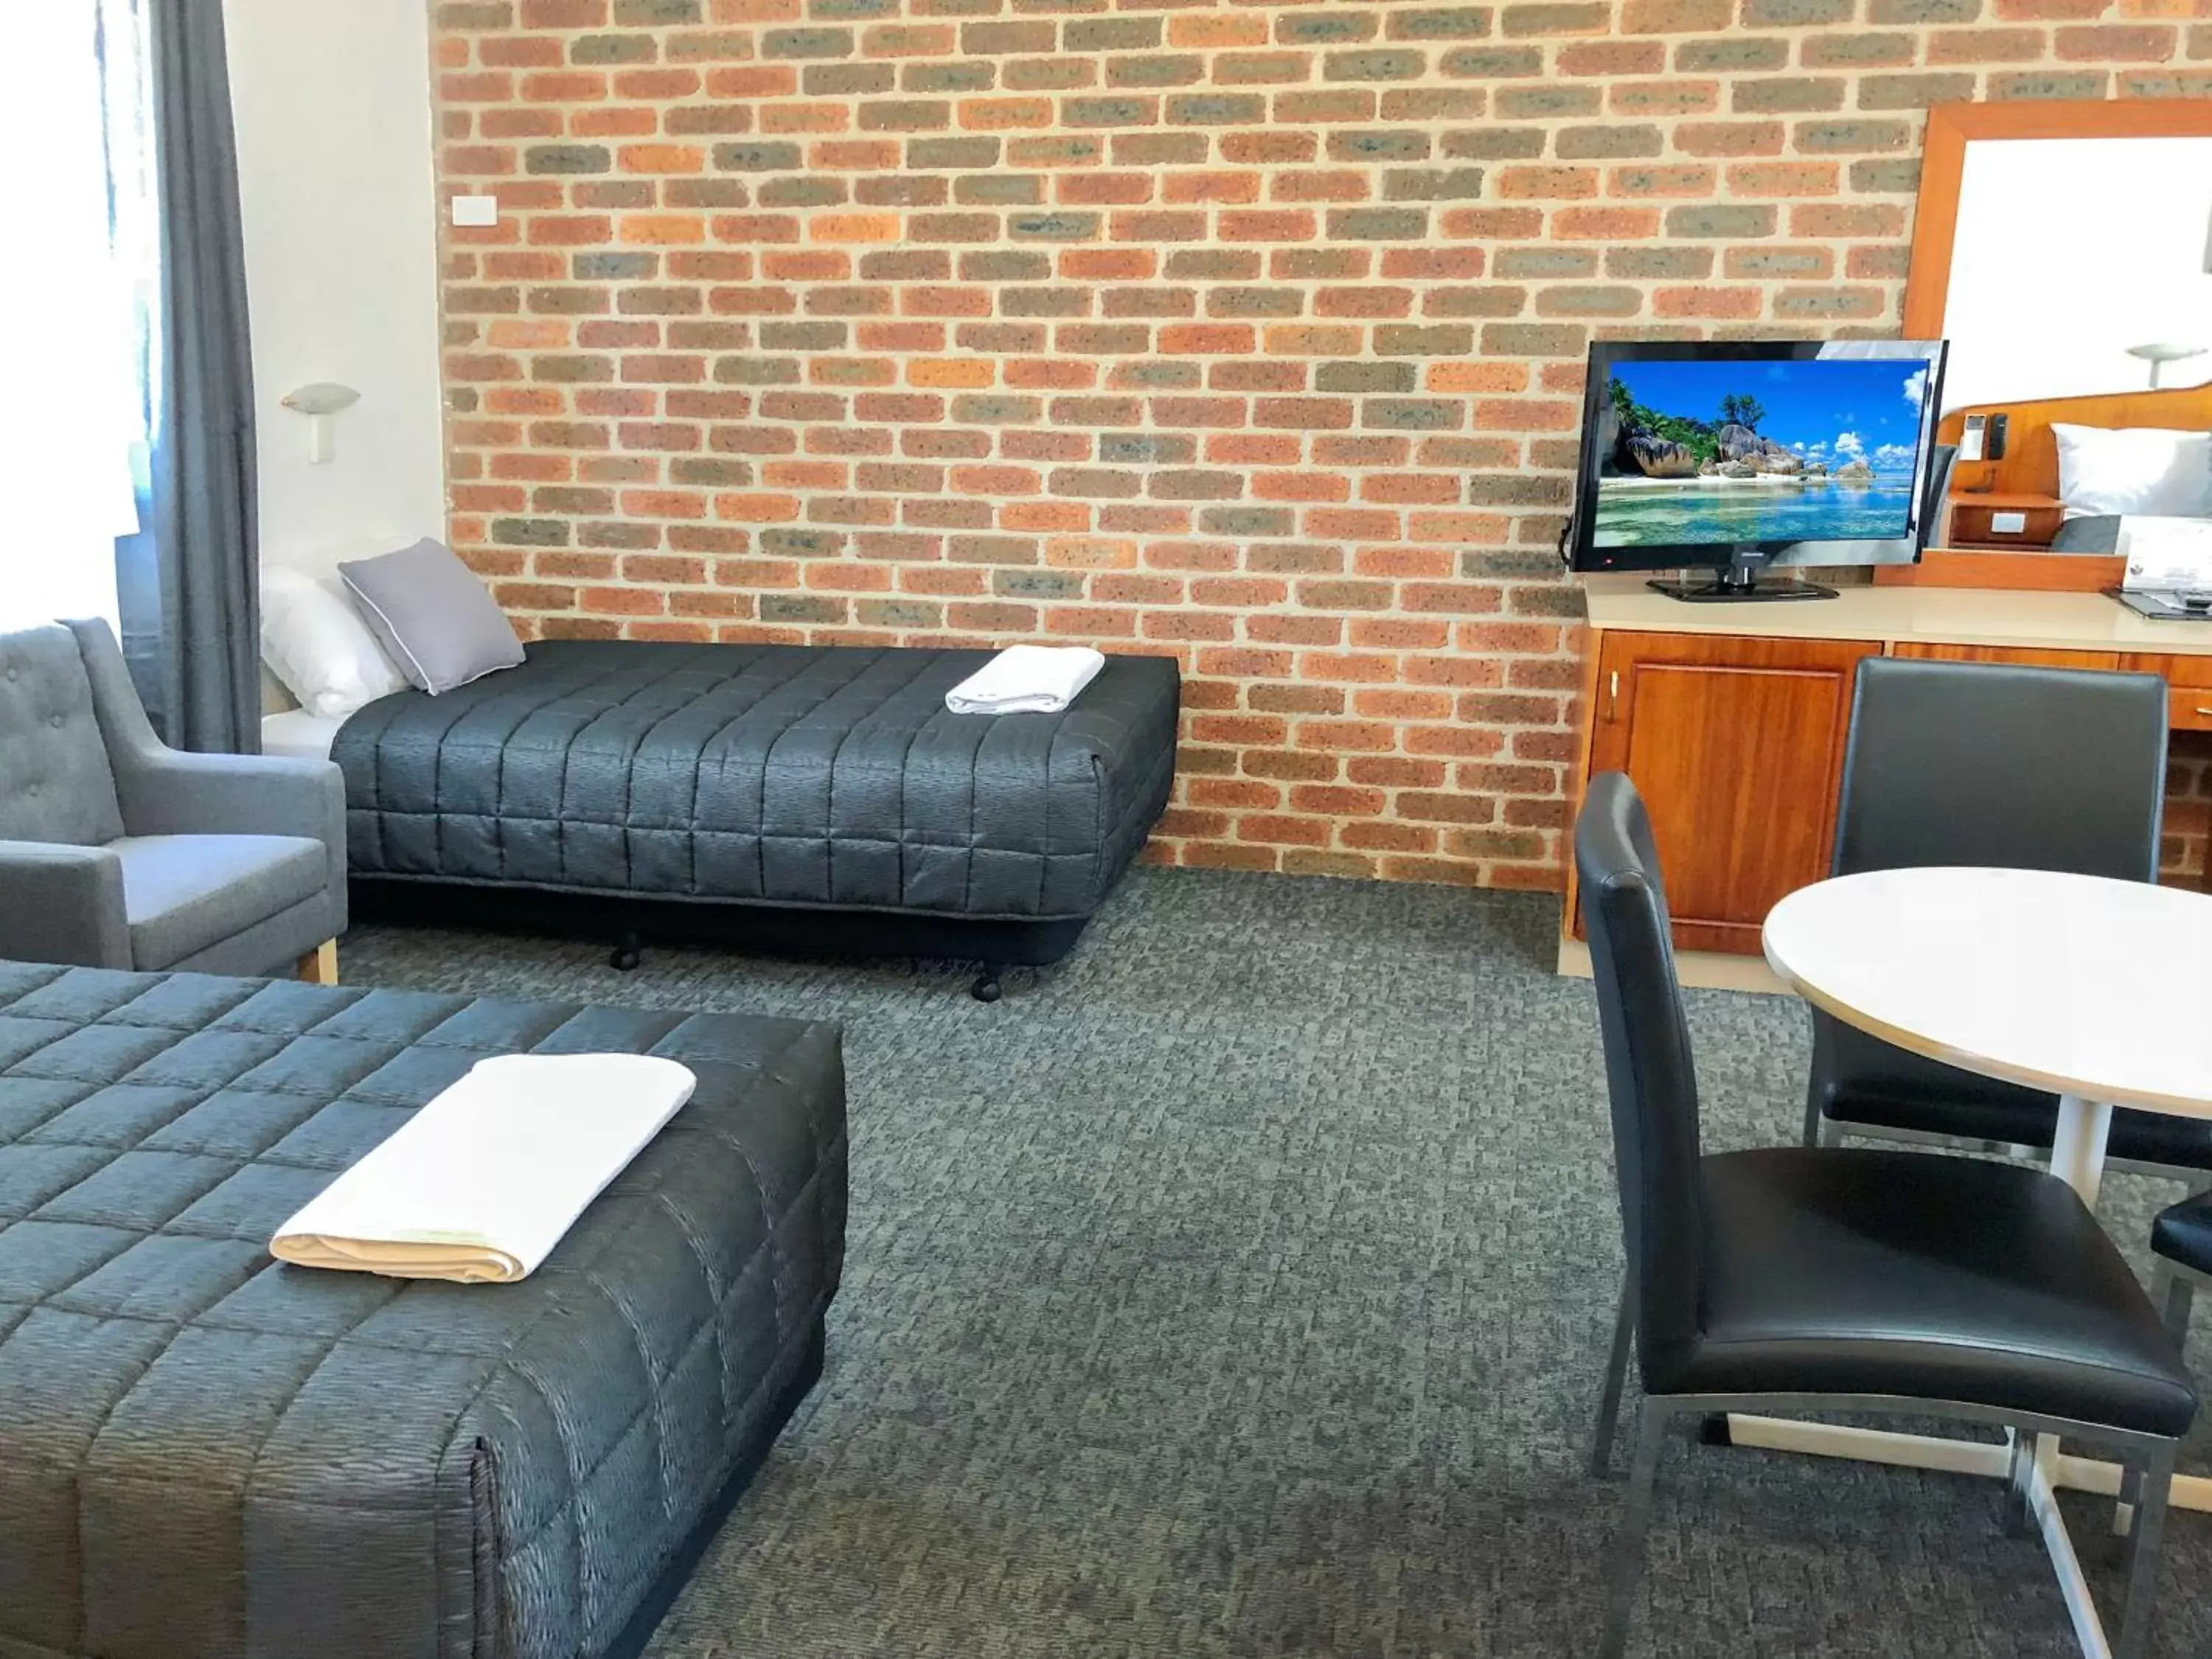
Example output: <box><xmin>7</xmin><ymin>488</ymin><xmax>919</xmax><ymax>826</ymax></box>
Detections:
<box><xmin>115</xmin><ymin>0</ymin><xmax>261</xmax><ymax>752</ymax></box>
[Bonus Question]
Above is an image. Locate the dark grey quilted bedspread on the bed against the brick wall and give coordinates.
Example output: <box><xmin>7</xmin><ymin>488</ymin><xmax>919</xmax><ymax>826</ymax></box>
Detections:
<box><xmin>332</xmin><ymin>639</ymin><xmax>1179</xmax><ymax>920</ymax></box>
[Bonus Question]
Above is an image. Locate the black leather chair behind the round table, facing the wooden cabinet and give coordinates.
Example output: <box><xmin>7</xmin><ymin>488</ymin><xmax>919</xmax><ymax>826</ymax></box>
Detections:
<box><xmin>1805</xmin><ymin>657</ymin><xmax>2212</xmax><ymax>1186</ymax></box>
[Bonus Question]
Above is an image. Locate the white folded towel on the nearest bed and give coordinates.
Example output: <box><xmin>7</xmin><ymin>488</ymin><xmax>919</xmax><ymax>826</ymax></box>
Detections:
<box><xmin>270</xmin><ymin>1055</ymin><xmax>699</xmax><ymax>1285</ymax></box>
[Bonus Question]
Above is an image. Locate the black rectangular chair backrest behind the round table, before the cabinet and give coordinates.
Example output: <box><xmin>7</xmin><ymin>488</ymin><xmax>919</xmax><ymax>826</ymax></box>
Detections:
<box><xmin>1832</xmin><ymin>657</ymin><xmax>2166</xmax><ymax>880</ymax></box>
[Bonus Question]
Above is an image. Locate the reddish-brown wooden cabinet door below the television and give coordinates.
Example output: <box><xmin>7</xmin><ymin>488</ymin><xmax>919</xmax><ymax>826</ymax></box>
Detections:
<box><xmin>1575</xmin><ymin>633</ymin><xmax>1882</xmax><ymax>956</ymax></box>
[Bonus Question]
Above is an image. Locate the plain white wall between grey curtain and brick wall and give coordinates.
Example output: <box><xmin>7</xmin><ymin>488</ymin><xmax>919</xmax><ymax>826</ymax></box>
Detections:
<box><xmin>223</xmin><ymin>0</ymin><xmax>445</xmax><ymax>580</ymax></box>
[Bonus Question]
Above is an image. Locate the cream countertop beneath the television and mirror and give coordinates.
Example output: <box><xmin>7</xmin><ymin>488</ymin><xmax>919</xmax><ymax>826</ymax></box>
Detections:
<box><xmin>1579</xmin><ymin>571</ymin><xmax>2212</xmax><ymax>657</ymax></box>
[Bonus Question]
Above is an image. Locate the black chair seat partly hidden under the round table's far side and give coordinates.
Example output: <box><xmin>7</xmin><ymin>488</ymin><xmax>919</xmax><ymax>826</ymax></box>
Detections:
<box><xmin>1814</xmin><ymin>1015</ymin><xmax>2212</xmax><ymax>1170</ymax></box>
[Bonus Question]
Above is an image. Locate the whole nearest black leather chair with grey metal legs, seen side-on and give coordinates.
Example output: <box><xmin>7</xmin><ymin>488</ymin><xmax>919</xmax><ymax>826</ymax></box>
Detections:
<box><xmin>1575</xmin><ymin>772</ymin><xmax>2197</xmax><ymax>1659</ymax></box>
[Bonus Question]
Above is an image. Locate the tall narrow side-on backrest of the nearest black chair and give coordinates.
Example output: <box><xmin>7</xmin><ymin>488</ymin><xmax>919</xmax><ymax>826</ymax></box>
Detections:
<box><xmin>1575</xmin><ymin>772</ymin><xmax>1703</xmax><ymax>1369</ymax></box>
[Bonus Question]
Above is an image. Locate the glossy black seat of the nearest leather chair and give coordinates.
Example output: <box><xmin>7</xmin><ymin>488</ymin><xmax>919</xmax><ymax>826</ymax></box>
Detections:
<box><xmin>1644</xmin><ymin>1146</ymin><xmax>2197</xmax><ymax>1436</ymax></box>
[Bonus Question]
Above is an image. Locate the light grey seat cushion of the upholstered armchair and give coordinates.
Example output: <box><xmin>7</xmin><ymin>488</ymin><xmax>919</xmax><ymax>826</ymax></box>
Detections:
<box><xmin>108</xmin><ymin>836</ymin><xmax>330</xmax><ymax>971</ymax></box>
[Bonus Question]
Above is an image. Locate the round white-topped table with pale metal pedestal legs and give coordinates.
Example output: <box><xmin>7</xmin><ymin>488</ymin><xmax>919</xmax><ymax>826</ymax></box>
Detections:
<box><xmin>1730</xmin><ymin>869</ymin><xmax>2212</xmax><ymax>1655</ymax></box>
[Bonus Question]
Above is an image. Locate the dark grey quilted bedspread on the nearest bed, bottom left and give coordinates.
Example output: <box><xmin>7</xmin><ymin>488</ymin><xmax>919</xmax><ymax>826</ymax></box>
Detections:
<box><xmin>0</xmin><ymin>962</ymin><xmax>845</xmax><ymax>1659</ymax></box>
